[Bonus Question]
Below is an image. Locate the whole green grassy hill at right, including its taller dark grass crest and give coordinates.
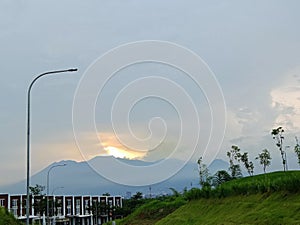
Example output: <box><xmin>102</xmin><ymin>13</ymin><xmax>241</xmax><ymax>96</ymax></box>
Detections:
<box><xmin>110</xmin><ymin>171</ymin><xmax>300</xmax><ymax>225</ymax></box>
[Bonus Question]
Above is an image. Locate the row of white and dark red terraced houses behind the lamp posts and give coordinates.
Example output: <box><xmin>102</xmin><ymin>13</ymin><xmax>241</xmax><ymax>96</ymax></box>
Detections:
<box><xmin>0</xmin><ymin>194</ymin><xmax>123</xmax><ymax>225</ymax></box>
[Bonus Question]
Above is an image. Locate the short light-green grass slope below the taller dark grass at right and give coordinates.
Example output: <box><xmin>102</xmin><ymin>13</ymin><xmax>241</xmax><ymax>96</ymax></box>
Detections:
<box><xmin>153</xmin><ymin>192</ymin><xmax>300</xmax><ymax>225</ymax></box>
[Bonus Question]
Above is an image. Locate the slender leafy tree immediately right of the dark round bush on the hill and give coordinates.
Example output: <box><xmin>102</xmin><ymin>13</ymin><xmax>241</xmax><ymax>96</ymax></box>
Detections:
<box><xmin>227</xmin><ymin>145</ymin><xmax>243</xmax><ymax>178</ymax></box>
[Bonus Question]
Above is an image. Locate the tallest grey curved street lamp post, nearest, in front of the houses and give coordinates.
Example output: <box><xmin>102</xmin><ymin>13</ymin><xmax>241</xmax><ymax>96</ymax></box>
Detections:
<box><xmin>26</xmin><ymin>69</ymin><xmax>77</xmax><ymax>225</ymax></box>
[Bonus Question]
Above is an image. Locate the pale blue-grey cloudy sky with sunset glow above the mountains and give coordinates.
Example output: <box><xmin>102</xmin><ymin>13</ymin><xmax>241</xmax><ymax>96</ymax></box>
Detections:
<box><xmin>0</xmin><ymin>0</ymin><xmax>300</xmax><ymax>185</ymax></box>
